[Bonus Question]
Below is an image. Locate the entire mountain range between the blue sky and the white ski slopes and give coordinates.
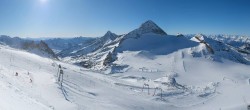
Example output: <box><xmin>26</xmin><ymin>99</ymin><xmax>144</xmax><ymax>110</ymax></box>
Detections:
<box><xmin>0</xmin><ymin>20</ymin><xmax>250</xmax><ymax>70</ymax></box>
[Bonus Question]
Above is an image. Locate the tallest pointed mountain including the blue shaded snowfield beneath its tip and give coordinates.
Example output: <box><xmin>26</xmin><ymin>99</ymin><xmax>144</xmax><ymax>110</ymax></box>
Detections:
<box><xmin>116</xmin><ymin>21</ymin><xmax>198</xmax><ymax>55</ymax></box>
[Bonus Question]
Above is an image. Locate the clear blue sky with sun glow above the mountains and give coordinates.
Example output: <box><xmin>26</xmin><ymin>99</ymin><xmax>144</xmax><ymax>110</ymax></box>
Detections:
<box><xmin>0</xmin><ymin>0</ymin><xmax>250</xmax><ymax>37</ymax></box>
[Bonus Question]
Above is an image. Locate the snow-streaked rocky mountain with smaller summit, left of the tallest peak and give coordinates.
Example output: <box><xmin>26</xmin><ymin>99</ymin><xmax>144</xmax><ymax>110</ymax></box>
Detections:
<box><xmin>58</xmin><ymin>31</ymin><xmax>122</xmax><ymax>67</ymax></box>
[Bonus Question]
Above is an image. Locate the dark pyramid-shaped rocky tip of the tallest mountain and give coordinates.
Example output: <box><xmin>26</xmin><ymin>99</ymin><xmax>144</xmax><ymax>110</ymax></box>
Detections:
<box><xmin>139</xmin><ymin>20</ymin><xmax>167</xmax><ymax>35</ymax></box>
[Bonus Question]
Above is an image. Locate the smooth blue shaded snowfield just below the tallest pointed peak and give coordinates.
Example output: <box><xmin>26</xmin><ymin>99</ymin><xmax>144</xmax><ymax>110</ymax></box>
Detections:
<box><xmin>116</xmin><ymin>33</ymin><xmax>198</xmax><ymax>55</ymax></box>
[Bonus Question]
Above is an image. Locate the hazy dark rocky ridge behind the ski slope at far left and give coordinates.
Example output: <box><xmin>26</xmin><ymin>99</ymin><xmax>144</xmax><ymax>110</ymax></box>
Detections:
<box><xmin>0</xmin><ymin>35</ymin><xmax>58</xmax><ymax>59</ymax></box>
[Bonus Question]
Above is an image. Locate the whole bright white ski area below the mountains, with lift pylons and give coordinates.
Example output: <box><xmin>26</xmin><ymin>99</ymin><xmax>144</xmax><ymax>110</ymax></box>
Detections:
<box><xmin>0</xmin><ymin>43</ymin><xmax>250</xmax><ymax>110</ymax></box>
